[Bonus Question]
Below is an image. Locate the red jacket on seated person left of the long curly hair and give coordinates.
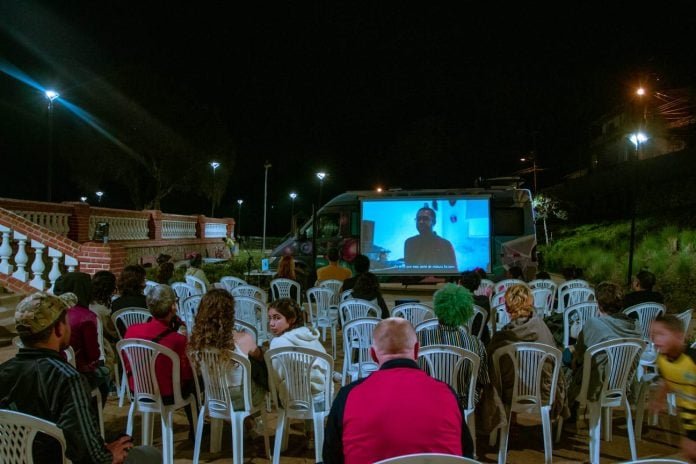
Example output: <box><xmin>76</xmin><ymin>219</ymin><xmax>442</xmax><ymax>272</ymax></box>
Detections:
<box><xmin>124</xmin><ymin>317</ymin><xmax>193</xmax><ymax>396</ymax></box>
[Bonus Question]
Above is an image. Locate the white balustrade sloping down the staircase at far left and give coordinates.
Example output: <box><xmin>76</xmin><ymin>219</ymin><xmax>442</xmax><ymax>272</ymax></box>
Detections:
<box><xmin>0</xmin><ymin>224</ymin><xmax>78</xmax><ymax>290</ymax></box>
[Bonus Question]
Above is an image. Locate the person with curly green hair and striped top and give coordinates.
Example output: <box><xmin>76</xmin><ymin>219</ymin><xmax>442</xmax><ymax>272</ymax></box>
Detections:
<box><xmin>418</xmin><ymin>284</ymin><xmax>491</xmax><ymax>402</ymax></box>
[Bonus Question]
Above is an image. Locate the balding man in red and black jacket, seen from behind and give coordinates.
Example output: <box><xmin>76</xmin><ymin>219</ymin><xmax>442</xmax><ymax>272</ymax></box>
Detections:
<box><xmin>323</xmin><ymin>317</ymin><xmax>473</xmax><ymax>464</ymax></box>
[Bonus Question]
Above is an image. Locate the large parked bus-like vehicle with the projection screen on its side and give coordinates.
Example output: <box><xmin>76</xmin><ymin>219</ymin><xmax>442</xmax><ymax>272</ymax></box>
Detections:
<box><xmin>271</xmin><ymin>177</ymin><xmax>537</xmax><ymax>283</ymax></box>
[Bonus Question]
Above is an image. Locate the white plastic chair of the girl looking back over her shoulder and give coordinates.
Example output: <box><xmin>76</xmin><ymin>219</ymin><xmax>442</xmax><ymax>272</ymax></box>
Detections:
<box><xmin>264</xmin><ymin>347</ymin><xmax>333</xmax><ymax>464</ymax></box>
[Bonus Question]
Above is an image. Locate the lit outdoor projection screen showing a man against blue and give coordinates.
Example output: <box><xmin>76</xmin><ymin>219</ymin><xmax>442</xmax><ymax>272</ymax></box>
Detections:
<box><xmin>360</xmin><ymin>196</ymin><xmax>491</xmax><ymax>275</ymax></box>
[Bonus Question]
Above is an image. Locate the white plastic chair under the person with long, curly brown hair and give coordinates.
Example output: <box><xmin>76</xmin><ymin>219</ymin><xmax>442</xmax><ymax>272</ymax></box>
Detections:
<box><xmin>191</xmin><ymin>348</ymin><xmax>271</xmax><ymax>464</ymax></box>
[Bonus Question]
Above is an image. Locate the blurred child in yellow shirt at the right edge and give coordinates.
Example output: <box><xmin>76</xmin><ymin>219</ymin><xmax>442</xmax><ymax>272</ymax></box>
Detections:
<box><xmin>650</xmin><ymin>314</ymin><xmax>696</xmax><ymax>462</ymax></box>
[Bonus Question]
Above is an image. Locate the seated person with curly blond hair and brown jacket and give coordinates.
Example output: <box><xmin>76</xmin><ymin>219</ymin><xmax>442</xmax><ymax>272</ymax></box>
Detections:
<box><xmin>486</xmin><ymin>284</ymin><xmax>569</xmax><ymax>418</ymax></box>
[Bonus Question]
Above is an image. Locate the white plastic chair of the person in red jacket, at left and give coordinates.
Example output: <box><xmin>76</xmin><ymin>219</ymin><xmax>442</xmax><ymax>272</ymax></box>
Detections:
<box><xmin>116</xmin><ymin>338</ymin><xmax>198</xmax><ymax>464</ymax></box>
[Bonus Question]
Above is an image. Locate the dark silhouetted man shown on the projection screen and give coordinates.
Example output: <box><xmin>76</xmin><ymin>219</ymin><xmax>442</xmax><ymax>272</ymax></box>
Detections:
<box><xmin>404</xmin><ymin>206</ymin><xmax>457</xmax><ymax>270</ymax></box>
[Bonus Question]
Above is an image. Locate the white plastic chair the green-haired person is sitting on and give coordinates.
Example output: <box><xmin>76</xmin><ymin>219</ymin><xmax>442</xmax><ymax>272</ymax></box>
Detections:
<box><xmin>418</xmin><ymin>345</ymin><xmax>481</xmax><ymax>456</ymax></box>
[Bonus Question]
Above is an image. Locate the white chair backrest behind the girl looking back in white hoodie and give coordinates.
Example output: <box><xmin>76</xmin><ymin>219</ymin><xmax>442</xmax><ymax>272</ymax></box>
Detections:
<box><xmin>264</xmin><ymin>346</ymin><xmax>333</xmax><ymax>419</ymax></box>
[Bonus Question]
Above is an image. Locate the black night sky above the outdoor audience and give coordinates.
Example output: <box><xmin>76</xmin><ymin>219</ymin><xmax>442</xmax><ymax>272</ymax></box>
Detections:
<box><xmin>0</xmin><ymin>0</ymin><xmax>696</xmax><ymax>233</ymax></box>
